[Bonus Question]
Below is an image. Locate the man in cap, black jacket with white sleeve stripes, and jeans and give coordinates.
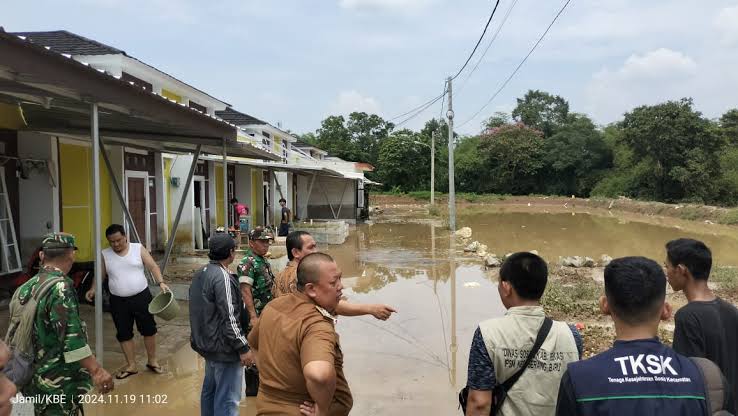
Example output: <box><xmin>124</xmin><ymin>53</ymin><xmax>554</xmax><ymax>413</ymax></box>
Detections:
<box><xmin>190</xmin><ymin>233</ymin><xmax>254</xmax><ymax>416</ymax></box>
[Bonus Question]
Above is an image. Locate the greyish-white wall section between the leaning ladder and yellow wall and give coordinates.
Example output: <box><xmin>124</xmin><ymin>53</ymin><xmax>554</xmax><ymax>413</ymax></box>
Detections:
<box><xmin>15</xmin><ymin>131</ymin><xmax>60</xmax><ymax>259</ymax></box>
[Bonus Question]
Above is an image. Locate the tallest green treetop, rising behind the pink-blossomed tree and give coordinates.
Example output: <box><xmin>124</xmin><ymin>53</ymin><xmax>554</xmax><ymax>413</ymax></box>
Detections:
<box><xmin>512</xmin><ymin>90</ymin><xmax>569</xmax><ymax>137</ymax></box>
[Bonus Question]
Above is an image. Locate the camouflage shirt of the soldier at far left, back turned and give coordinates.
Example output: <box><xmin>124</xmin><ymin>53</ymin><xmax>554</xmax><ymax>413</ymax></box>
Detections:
<box><xmin>18</xmin><ymin>268</ymin><xmax>92</xmax><ymax>415</ymax></box>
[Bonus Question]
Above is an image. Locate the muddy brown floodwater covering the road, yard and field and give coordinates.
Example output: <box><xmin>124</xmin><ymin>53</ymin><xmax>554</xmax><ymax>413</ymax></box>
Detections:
<box><xmin>79</xmin><ymin>212</ymin><xmax>738</xmax><ymax>416</ymax></box>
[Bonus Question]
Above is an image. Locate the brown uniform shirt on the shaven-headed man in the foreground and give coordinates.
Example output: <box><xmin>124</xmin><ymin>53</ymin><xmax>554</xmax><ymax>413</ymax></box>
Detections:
<box><xmin>248</xmin><ymin>292</ymin><xmax>353</xmax><ymax>416</ymax></box>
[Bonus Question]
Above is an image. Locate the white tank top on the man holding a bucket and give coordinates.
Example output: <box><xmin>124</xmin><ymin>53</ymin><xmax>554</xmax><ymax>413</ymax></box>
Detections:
<box><xmin>103</xmin><ymin>243</ymin><xmax>149</xmax><ymax>297</ymax></box>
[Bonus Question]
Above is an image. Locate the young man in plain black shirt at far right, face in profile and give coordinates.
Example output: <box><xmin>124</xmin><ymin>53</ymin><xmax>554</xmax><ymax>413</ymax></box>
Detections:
<box><xmin>666</xmin><ymin>238</ymin><xmax>738</xmax><ymax>413</ymax></box>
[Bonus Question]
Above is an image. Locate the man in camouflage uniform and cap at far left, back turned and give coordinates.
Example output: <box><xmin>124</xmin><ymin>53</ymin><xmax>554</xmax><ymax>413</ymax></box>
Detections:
<box><xmin>18</xmin><ymin>233</ymin><xmax>114</xmax><ymax>415</ymax></box>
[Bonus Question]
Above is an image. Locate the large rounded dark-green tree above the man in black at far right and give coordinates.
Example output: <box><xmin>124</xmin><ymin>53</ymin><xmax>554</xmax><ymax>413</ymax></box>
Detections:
<box><xmin>622</xmin><ymin>98</ymin><xmax>723</xmax><ymax>202</ymax></box>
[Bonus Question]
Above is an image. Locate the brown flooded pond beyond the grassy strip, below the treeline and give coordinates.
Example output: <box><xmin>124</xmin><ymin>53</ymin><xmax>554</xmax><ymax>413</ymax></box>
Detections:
<box><xmin>457</xmin><ymin>212</ymin><xmax>738</xmax><ymax>266</ymax></box>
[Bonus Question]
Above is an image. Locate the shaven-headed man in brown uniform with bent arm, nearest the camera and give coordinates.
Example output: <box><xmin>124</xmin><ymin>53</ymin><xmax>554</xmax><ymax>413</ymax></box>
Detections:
<box><xmin>248</xmin><ymin>253</ymin><xmax>353</xmax><ymax>416</ymax></box>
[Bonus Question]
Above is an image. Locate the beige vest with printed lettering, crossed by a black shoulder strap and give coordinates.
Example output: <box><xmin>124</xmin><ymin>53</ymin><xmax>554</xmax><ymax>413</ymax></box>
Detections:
<box><xmin>479</xmin><ymin>306</ymin><xmax>579</xmax><ymax>416</ymax></box>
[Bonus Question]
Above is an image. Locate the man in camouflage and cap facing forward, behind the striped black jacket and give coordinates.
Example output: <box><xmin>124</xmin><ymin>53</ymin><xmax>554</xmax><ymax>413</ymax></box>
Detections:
<box><xmin>237</xmin><ymin>227</ymin><xmax>274</xmax><ymax>328</ymax></box>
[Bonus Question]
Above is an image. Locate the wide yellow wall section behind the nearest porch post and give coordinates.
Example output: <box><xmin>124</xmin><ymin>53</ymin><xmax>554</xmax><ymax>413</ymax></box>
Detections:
<box><xmin>59</xmin><ymin>142</ymin><xmax>112</xmax><ymax>261</ymax></box>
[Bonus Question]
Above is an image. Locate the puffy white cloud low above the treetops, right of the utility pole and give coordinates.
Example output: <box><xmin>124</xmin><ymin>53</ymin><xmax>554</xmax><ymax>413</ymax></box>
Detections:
<box><xmin>585</xmin><ymin>48</ymin><xmax>698</xmax><ymax>122</ymax></box>
